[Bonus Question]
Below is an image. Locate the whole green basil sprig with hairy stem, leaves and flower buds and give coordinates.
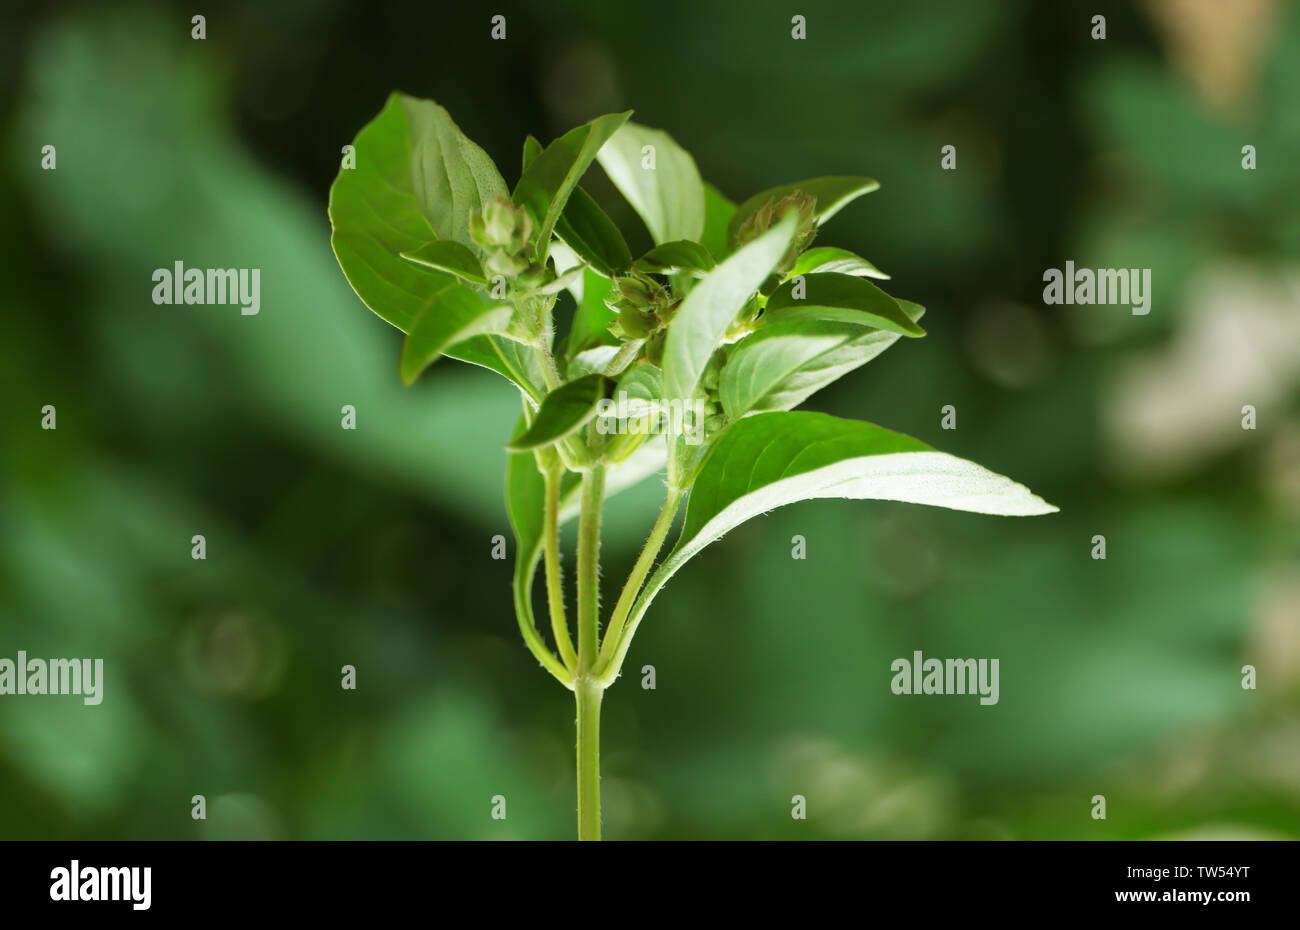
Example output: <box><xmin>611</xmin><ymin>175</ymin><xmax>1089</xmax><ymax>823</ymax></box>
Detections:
<box><xmin>329</xmin><ymin>94</ymin><xmax>1056</xmax><ymax>839</ymax></box>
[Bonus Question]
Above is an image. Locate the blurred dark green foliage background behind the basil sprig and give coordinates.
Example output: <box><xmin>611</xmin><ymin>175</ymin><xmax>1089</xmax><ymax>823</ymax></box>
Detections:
<box><xmin>0</xmin><ymin>0</ymin><xmax>1300</xmax><ymax>839</ymax></box>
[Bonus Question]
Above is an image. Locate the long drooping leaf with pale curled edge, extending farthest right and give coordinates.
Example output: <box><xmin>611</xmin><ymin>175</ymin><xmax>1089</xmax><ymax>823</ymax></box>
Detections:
<box><xmin>631</xmin><ymin>411</ymin><xmax>1057</xmax><ymax>639</ymax></box>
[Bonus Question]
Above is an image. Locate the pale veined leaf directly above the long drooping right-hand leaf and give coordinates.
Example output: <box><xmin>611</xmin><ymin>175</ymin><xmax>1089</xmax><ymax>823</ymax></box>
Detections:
<box><xmin>718</xmin><ymin>300</ymin><xmax>926</xmax><ymax>420</ymax></box>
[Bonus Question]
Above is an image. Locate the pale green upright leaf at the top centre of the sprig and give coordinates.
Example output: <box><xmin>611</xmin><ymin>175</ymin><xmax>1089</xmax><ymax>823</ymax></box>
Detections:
<box><xmin>597</xmin><ymin>122</ymin><xmax>705</xmax><ymax>243</ymax></box>
